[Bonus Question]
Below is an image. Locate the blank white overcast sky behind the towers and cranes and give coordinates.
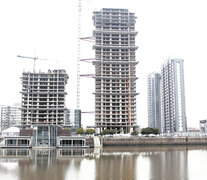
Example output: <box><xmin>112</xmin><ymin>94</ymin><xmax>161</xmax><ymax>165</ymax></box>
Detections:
<box><xmin>0</xmin><ymin>0</ymin><xmax>207</xmax><ymax>128</ymax></box>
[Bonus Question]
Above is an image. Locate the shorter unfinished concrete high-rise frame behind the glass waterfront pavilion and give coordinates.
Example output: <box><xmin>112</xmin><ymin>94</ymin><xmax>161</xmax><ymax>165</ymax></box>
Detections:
<box><xmin>21</xmin><ymin>70</ymin><xmax>68</xmax><ymax>126</ymax></box>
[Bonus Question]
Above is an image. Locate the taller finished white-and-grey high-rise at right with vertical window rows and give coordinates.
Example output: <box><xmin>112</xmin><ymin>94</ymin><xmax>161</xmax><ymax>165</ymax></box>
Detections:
<box><xmin>160</xmin><ymin>59</ymin><xmax>187</xmax><ymax>133</ymax></box>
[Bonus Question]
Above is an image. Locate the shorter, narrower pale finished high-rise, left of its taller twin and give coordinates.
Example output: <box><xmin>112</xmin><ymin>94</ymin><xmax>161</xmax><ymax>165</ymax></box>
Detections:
<box><xmin>147</xmin><ymin>73</ymin><xmax>161</xmax><ymax>132</ymax></box>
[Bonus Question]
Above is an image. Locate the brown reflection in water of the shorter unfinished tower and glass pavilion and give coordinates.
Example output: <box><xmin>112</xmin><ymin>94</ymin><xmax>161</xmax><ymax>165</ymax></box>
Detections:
<box><xmin>19</xmin><ymin>150</ymin><xmax>71</xmax><ymax>180</ymax></box>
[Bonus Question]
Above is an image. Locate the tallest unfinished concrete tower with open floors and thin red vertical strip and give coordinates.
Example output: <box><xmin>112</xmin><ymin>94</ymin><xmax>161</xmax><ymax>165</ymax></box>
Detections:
<box><xmin>93</xmin><ymin>8</ymin><xmax>138</xmax><ymax>133</ymax></box>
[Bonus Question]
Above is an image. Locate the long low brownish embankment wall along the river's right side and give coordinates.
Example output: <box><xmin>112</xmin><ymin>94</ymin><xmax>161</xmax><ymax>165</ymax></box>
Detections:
<box><xmin>101</xmin><ymin>137</ymin><xmax>207</xmax><ymax>146</ymax></box>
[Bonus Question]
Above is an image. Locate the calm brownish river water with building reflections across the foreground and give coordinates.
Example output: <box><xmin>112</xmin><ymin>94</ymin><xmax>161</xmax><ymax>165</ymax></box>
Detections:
<box><xmin>0</xmin><ymin>146</ymin><xmax>207</xmax><ymax>180</ymax></box>
